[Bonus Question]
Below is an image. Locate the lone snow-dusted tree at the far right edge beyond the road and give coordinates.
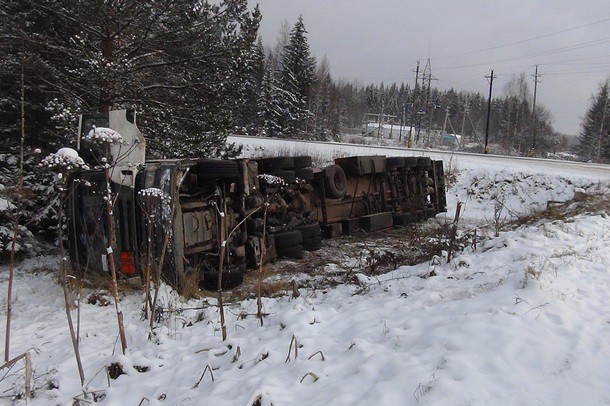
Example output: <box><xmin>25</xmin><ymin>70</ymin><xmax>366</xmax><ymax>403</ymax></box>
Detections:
<box><xmin>579</xmin><ymin>80</ymin><xmax>610</xmax><ymax>162</ymax></box>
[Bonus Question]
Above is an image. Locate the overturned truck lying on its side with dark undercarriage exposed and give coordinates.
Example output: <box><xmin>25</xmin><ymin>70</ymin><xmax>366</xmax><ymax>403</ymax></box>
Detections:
<box><xmin>66</xmin><ymin>110</ymin><xmax>446</xmax><ymax>289</ymax></box>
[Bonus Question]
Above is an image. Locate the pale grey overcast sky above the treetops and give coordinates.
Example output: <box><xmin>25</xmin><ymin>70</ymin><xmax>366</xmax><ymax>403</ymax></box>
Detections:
<box><xmin>251</xmin><ymin>0</ymin><xmax>610</xmax><ymax>134</ymax></box>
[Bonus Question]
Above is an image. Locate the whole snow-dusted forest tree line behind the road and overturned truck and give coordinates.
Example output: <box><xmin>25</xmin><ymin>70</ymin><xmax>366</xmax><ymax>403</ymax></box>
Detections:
<box><xmin>0</xmin><ymin>0</ymin><xmax>610</xmax><ymax>160</ymax></box>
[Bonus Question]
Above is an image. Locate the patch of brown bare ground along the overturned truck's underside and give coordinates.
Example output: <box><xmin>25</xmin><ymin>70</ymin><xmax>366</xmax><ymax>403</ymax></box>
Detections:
<box><xmin>227</xmin><ymin>216</ymin><xmax>471</xmax><ymax>300</ymax></box>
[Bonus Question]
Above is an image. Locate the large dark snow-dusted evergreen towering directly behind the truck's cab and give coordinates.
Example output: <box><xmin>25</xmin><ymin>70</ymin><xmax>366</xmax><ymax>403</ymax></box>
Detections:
<box><xmin>0</xmin><ymin>0</ymin><xmax>260</xmax><ymax>156</ymax></box>
